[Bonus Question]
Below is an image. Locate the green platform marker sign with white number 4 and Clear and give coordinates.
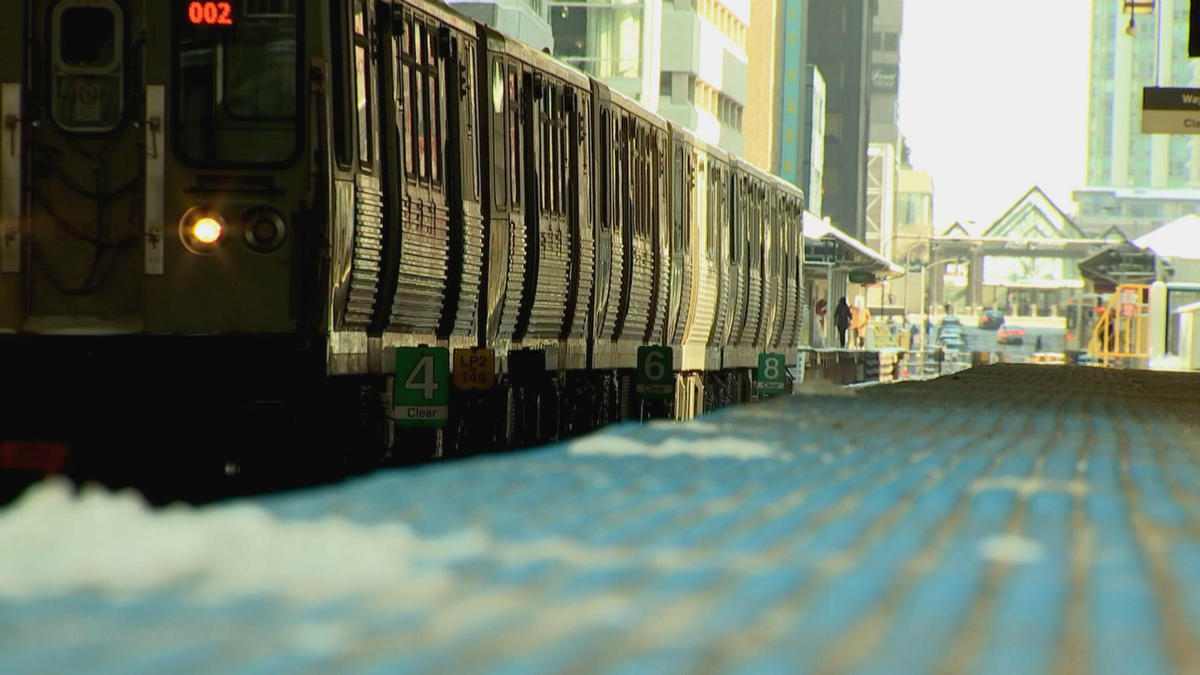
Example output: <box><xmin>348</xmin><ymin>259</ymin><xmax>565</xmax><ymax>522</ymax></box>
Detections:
<box><xmin>391</xmin><ymin>347</ymin><xmax>450</xmax><ymax>426</ymax></box>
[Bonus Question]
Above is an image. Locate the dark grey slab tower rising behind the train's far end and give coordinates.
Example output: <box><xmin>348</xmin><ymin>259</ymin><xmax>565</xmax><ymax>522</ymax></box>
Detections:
<box><xmin>805</xmin><ymin>0</ymin><xmax>875</xmax><ymax>240</ymax></box>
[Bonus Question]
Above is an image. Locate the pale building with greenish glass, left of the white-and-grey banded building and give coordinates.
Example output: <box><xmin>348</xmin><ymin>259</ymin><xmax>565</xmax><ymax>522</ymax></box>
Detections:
<box><xmin>548</xmin><ymin>0</ymin><xmax>662</xmax><ymax>110</ymax></box>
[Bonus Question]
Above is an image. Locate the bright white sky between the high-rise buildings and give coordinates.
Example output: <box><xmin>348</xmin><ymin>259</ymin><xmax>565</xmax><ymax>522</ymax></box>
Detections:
<box><xmin>900</xmin><ymin>0</ymin><xmax>1089</xmax><ymax>231</ymax></box>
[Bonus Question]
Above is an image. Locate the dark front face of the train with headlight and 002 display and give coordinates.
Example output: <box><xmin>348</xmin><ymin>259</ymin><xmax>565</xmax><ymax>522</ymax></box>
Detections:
<box><xmin>0</xmin><ymin>0</ymin><xmax>345</xmax><ymax>494</ymax></box>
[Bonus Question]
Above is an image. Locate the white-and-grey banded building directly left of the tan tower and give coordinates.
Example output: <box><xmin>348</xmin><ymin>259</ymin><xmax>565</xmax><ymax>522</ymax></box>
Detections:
<box><xmin>659</xmin><ymin>0</ymin><xmax>750</xmax><ymax>155</ymax></box>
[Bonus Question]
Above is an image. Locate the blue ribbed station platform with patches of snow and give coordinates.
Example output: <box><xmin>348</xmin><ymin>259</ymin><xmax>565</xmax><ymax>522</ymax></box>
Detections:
<box><xmin>0</xmin><ymin>365</ymin><xmax>1200</xmax><ymax>674</ymax></box>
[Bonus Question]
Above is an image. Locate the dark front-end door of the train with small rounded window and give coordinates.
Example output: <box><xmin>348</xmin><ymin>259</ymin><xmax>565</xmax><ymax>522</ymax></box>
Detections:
<box><xmin>10</xmin><ymin>0</ymin><xmax>146</xmax><ymax>333</ymax></box>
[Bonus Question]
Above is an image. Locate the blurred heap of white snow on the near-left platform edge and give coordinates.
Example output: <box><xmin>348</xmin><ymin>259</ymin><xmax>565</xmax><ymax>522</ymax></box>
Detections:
<box><xmin>0</xmin><ymin>480</ymin><xmax>487</xmax><ymax>603</ymax></box>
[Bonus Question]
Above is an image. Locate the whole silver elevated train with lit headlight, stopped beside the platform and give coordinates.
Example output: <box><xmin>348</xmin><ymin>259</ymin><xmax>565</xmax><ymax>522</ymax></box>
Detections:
<box><xmin>0</xmin><ymin>0</ymin><xmax>804</xmax><ymax>485</ymax></box>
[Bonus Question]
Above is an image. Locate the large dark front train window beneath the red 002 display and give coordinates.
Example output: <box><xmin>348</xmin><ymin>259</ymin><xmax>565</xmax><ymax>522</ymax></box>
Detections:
<box><xmin>170</xmin><ymin>0</ymin><xmax>304</xmax><ymax>165</ymax></box>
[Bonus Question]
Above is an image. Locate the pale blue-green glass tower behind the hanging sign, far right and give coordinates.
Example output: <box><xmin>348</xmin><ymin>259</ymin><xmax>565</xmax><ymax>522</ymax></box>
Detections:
<box><xmin>1081</xmin><ymin>0</ymin><xmax>1200</xmax><ymax>190</ymax></box>
